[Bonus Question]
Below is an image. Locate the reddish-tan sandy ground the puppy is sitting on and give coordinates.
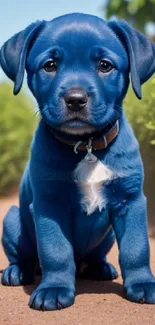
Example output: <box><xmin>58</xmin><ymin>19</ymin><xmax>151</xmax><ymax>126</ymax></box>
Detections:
<box><xmin>0</xmin><ymin>192</ymin><xmax>155</xmax><ymax>325</ymax></box>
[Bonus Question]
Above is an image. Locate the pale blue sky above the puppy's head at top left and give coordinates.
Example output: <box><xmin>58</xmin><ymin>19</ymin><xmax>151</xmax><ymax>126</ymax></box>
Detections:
<box><xmin>0</xmin><ymin>0</ymin><xmax>103</xmax><ymax>80</ymax></box>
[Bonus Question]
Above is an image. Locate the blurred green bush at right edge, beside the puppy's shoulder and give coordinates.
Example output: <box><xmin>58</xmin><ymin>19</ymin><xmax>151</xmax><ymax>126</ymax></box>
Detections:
<box><xmin>124</xmin><ymin>77</ymin><xmax>155</xmax><ymax>226</ymax></box>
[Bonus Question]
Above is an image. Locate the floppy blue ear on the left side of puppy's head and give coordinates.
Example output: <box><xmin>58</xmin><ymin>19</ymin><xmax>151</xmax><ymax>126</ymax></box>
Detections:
<box><xmin>0</xmin><ymin>21</ymin><xmax>43</xmax><ymax>95</ymax></box>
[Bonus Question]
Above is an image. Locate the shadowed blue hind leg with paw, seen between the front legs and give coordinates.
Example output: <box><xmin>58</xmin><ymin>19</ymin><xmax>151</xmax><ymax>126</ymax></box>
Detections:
<box><xmin>80</xmin><ymin>229</ymin><xmax>118</xmax><ymax>281</ymax></box>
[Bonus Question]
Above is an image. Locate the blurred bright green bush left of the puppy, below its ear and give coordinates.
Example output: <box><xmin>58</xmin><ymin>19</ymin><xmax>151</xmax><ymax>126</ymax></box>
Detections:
<box><xmin>0</xmin><ymin>83</ymin><xmax>36</xmax><ymax>194</ymax></box>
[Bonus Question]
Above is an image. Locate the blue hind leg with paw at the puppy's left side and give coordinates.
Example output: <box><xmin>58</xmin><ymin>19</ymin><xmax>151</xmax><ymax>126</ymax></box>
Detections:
<box><xmin>1</xmin><ymin>206</ymin><xmax>37</xmax><ymax>286</ymax></box>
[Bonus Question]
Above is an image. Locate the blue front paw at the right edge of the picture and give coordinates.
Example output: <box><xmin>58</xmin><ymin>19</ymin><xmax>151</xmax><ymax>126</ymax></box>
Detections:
<box><xmin>125</xmin><ymin>281</ymin><xmax>155</xmax><ymax>304</ymax></box>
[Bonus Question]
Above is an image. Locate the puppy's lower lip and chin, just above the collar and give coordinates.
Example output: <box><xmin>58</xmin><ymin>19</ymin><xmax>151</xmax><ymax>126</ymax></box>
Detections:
<box><xmin>54</xmin><ymin>119</ymin><xmax>96</xmax><ymax>135</ymax></box>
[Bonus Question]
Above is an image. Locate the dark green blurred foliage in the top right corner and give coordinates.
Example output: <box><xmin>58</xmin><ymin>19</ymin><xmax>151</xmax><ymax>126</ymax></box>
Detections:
<box><xmin>103</xmin><ymin>0</ymin><xmax>155</xmax><ymax>32</ymax></box>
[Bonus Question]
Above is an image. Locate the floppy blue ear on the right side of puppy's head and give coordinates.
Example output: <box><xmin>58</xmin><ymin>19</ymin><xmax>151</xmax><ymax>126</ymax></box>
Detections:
<box><xmin>108</xmin><ymin>20</ymin><xmax>155</xmax><ymax>99</ymax></box>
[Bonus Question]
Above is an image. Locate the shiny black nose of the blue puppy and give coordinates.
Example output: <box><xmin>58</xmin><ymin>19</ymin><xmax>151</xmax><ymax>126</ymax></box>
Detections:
<box><xmin>64</xmin><ymin>88</ymin><xmax>88</xmax><ymax>111</ymax></box>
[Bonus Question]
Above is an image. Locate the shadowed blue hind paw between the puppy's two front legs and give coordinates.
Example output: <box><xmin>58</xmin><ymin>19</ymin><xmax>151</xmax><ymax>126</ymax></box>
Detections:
<box><xmin>81</xmin><ymin>261</ymin><xmax>118</xmax><ymax>281</ymax></box>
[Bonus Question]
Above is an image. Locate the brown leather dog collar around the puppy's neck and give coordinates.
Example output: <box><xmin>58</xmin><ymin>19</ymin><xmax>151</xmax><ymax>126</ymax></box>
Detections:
<box><xmin>46</xmin><ymin>120</ymin><xmax>119</xmax><ymax>153</ymax></box>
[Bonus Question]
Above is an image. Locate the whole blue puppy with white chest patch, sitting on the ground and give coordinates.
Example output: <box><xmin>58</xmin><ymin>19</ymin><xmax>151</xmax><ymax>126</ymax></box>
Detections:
<box><xmin>1</xmin><ymin>14</ymin><xmax>155</xmax><ymax>310</ymax></box>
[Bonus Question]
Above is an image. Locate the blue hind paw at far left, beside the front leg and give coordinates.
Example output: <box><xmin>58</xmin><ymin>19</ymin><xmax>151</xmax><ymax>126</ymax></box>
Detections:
<box><xmin>1</xmin><ymin>264</ymin><xmax>34</xmax><ymax>286</ymax></box>
